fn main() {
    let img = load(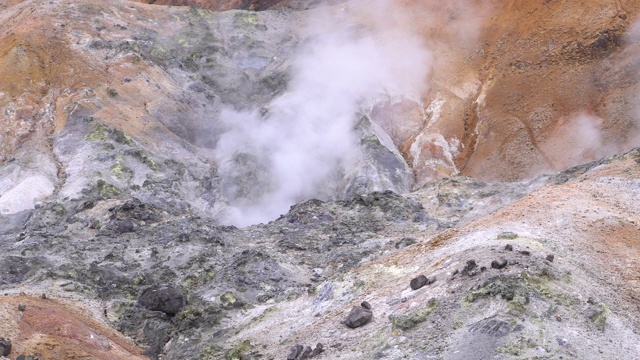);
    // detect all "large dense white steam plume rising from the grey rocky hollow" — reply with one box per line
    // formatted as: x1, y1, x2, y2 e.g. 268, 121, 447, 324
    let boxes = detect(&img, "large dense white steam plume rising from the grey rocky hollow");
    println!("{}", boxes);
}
216, 0, 432, 226
